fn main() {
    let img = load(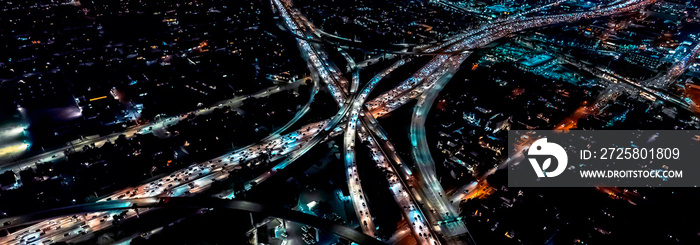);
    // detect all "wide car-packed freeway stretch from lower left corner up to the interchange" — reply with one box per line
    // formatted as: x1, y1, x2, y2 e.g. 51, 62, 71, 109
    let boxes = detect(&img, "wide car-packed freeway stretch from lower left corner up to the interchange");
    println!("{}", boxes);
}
0, 116, 334, 244
